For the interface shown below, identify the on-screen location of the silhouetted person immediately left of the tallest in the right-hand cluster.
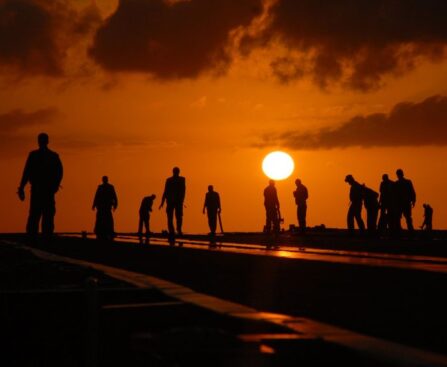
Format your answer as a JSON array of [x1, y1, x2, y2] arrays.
[[379, 173, 397, 232]]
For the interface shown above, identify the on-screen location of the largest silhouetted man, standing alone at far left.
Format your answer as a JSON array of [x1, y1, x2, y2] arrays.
[[17, 133, 63, 236]]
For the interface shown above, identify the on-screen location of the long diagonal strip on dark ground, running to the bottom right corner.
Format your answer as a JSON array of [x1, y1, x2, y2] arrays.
[[15, 244, 447, 367]]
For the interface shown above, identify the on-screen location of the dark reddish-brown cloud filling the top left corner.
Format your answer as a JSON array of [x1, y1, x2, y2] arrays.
[[0, 0, 100, 77]]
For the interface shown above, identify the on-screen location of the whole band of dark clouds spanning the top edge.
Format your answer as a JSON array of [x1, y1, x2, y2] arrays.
[[0, 0, 447, 91]]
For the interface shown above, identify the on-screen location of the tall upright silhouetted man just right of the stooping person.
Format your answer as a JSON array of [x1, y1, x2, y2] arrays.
[[159, 167, 186, 236]]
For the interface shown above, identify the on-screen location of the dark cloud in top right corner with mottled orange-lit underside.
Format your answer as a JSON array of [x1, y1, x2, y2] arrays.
[[242, 0, 447, 90]]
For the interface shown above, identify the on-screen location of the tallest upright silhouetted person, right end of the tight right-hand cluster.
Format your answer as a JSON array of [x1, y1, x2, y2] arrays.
[[395, 169, 416, 232]]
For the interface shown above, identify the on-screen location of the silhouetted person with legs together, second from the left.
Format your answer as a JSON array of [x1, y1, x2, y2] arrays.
[[92, 176, 118, 240]]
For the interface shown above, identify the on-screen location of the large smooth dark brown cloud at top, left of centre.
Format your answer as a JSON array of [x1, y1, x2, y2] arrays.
[[90, 0, 262, 79]]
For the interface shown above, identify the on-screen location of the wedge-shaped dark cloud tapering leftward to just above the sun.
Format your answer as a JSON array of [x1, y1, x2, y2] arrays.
[[261, 96, 447, 150]]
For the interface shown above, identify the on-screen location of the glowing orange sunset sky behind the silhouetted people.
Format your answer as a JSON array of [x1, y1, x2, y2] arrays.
[[0, 0, 447, 233]]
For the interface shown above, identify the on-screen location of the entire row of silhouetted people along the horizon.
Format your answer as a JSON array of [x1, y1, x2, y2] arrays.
[[18, 133, 433, 240]]
